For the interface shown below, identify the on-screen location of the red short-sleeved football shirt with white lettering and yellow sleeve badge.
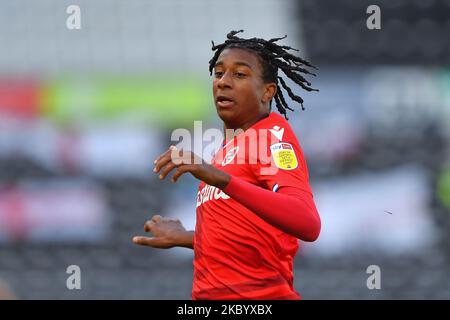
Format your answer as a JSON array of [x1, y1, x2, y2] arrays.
[[192, 112, 312, 299]]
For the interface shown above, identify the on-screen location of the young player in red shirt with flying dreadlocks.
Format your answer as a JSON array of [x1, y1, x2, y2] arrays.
[[133, 30, 321, 299]]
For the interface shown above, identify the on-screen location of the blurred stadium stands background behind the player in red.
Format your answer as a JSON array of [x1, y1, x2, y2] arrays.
[[0, 0, 450, 299]]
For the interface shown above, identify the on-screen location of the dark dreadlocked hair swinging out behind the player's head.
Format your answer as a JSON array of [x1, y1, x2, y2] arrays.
[[209, 30, 319, 119]]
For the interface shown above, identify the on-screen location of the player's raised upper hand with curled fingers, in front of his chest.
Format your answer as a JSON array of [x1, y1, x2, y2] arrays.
[[153, 146, 230, 189]]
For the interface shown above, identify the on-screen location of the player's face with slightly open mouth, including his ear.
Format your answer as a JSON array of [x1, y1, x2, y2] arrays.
[[213, 48, 276, 130]]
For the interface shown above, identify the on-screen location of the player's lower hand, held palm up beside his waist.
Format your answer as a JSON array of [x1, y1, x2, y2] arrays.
[[133, 215, 194, 249]]
